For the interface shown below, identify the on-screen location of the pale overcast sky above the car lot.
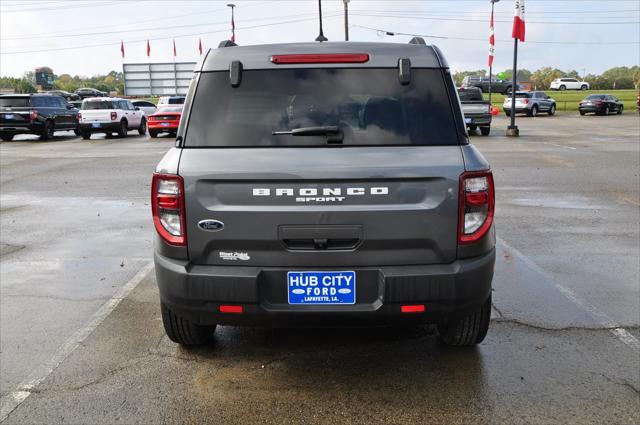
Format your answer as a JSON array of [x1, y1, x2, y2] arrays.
[[0, 0, 640, 76]]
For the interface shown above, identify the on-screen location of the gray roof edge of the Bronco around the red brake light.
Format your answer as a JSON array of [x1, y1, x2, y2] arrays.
[[202, 41, 449, 71]]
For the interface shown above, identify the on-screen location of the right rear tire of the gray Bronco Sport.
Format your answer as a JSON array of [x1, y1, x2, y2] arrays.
[[438, 296, 491, 347]]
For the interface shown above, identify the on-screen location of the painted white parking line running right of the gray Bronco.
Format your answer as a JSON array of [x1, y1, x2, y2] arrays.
[[496, 238, 640, 352]]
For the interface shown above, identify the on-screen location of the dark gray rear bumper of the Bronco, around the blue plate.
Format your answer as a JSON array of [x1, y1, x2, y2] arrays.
[[154, 249, 495, 326]]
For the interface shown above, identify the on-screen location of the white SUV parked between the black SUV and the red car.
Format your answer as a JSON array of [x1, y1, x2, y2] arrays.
[[78, 97, 147, 139]]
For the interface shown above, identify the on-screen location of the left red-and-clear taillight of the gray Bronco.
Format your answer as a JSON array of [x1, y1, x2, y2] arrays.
[[151, 173, 187, 246]]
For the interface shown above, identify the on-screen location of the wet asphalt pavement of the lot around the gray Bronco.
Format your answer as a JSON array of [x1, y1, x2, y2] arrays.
[[0, 113, 640, 423]]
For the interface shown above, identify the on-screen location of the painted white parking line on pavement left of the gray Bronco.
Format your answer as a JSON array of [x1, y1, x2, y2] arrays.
[[0, 261, 153, 422]]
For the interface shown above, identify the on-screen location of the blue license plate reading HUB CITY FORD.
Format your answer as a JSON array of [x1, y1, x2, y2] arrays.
[[287, 271, 356, 304]]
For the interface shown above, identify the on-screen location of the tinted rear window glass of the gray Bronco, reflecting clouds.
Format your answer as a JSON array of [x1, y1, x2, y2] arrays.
[[185, 68, 458, 147]]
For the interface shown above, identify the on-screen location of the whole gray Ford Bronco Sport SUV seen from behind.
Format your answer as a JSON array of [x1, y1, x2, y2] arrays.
[[151, 38, 495, 345]]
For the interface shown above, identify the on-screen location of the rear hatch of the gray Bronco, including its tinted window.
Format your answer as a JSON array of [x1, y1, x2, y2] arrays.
[[179, 68, 464, 267]]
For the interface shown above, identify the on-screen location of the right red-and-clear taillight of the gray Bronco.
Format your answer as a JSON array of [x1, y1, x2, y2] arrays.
[[458, 171, 495, 244]]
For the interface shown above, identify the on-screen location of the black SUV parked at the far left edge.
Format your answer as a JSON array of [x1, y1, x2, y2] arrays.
[[0, 93, 78, 141]]
